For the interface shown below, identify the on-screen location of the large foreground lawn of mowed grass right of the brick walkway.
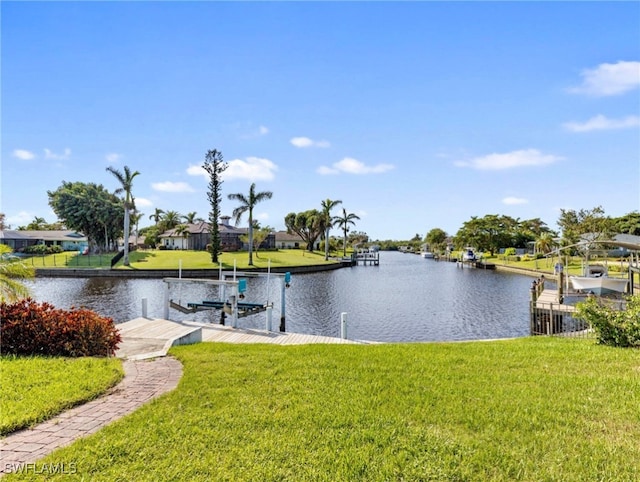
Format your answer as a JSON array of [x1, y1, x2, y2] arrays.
[[18, 338, 640, 481]]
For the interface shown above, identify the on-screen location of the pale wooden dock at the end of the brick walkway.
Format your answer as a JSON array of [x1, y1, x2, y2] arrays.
[[116, 317, 376, 360]]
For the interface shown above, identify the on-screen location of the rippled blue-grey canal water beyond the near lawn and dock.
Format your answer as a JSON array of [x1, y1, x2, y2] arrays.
[[23, 252, 531, 342]]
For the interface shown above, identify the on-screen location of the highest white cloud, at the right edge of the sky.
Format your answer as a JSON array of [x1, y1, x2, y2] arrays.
[[569, 61, 640, 97]]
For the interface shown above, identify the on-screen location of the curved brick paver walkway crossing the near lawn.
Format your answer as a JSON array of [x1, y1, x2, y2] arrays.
[[0, 357, 182, 474]]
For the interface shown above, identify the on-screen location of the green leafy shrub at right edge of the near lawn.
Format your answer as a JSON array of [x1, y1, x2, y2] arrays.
[[577, 295, 640, 347]]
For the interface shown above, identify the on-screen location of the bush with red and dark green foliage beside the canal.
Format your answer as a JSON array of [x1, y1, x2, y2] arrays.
[[0, 298, 122, 357]]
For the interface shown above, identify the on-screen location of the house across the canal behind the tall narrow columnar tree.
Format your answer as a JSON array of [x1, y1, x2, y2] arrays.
[[160, 216, 276, 251]]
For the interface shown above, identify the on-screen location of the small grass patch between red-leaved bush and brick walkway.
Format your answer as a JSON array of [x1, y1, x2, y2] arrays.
[[0, 355, 124, 435]]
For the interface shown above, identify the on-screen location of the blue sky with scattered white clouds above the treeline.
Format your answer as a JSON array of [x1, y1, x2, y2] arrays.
[[0, 1, 640, 240]]
